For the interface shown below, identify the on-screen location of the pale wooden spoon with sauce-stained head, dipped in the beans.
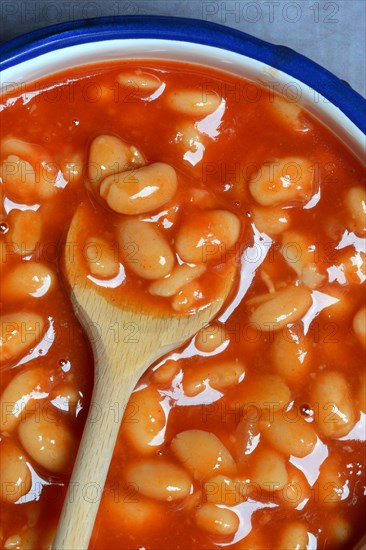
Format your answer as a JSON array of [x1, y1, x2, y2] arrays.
[[53, 205, 235, 550]]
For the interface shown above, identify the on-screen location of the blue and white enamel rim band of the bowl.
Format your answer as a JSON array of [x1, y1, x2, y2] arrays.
[[0, 12, 366, 548]]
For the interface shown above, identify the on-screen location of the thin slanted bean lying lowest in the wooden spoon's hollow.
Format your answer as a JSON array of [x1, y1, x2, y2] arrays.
[[149, 264, 206, 297]]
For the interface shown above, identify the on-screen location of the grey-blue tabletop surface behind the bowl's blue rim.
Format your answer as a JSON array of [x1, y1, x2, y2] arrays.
[[0, 0, 366, 97]]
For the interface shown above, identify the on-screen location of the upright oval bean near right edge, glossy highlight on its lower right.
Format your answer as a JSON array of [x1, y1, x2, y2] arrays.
[[310, 370, 357, 438]]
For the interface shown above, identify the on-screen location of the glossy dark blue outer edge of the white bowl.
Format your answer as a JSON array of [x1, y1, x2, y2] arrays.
[[0, 15, 366, 134]]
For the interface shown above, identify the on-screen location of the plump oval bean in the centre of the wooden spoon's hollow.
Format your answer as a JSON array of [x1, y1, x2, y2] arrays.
[[119, 218, 174, 279]]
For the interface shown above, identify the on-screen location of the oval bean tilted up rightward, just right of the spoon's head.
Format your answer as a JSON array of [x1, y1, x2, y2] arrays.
[[251, 285, 312, 331]]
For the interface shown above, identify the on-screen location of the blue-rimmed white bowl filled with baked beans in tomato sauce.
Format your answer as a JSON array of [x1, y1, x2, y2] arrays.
[[0, 17, 366, 550]]
